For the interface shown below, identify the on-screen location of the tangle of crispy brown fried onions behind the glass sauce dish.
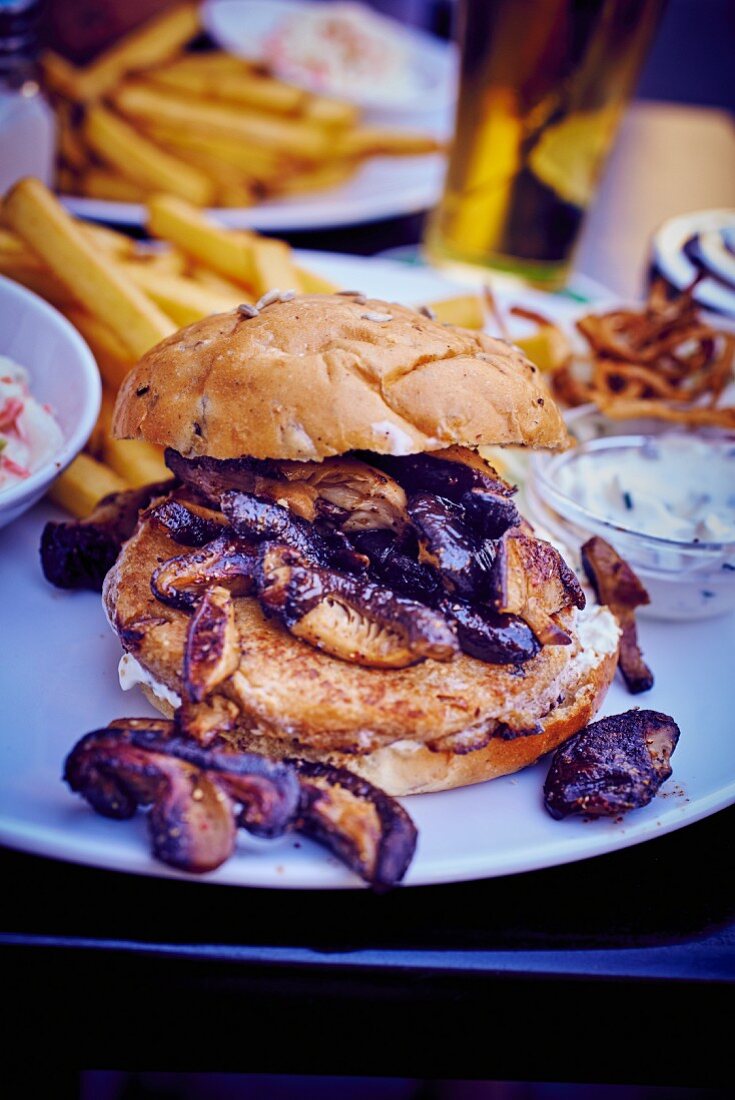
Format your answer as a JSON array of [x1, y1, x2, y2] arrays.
[[543, 282, 735, 429]]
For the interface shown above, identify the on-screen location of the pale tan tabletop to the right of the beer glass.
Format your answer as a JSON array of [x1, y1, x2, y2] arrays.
[[574, 101, 735, 297]]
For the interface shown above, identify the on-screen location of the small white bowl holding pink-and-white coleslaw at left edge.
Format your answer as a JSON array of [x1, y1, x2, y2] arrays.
[[0, 276, 101, 527]]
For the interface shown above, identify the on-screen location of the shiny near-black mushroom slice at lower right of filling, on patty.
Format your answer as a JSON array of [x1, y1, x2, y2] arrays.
[[440, 600, 541, 664]]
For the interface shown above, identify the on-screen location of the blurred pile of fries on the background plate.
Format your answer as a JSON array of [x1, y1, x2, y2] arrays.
[[42, 3, 439, 207]]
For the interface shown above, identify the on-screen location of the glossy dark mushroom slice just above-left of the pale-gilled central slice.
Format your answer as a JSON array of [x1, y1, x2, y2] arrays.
[[221, 492, 366, 572]]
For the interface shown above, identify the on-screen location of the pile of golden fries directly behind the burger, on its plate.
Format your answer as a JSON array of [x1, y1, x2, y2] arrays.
[[0, 179, 484, 517]]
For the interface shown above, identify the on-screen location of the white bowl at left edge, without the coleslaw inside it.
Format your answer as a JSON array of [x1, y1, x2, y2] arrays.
[[0, 276, 102, 527]]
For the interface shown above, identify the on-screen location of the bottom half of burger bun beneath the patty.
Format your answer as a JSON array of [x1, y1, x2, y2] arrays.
[[140, 607, 619, 795]]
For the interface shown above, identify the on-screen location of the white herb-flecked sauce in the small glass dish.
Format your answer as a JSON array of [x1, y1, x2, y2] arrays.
[[553, 435, 735, 543]]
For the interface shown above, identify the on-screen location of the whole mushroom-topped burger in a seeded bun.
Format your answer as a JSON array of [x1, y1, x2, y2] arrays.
[[103, 293, 619, 795]]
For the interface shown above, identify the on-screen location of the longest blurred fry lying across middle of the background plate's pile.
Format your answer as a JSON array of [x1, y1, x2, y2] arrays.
[[114, 81, 334, 161]]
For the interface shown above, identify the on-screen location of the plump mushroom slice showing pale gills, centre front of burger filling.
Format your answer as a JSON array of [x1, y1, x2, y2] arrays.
[[259, 543, 457, 669]]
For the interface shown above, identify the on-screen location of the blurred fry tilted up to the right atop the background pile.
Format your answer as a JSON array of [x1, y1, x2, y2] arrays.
[[49, 3, 200, 102]]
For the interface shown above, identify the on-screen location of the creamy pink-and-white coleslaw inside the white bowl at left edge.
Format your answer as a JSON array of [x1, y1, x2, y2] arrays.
[[0, 355, 64, 492]]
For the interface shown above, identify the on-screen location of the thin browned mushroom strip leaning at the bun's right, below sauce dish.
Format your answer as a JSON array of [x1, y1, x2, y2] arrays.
[[581, 535, 654, 695]]
